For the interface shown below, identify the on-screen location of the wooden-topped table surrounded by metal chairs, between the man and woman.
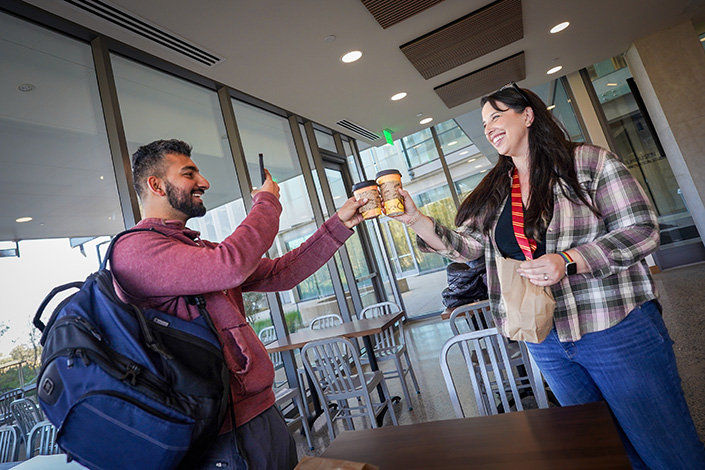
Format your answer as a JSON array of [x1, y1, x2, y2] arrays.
[[265, 310, 404, 426]]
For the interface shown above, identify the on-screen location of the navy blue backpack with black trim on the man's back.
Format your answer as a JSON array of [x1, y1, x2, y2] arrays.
[[34, 229, 230, 470]]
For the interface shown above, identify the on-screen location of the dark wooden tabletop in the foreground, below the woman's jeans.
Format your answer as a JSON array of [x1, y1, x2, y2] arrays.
[[321, 402, 631, 470]]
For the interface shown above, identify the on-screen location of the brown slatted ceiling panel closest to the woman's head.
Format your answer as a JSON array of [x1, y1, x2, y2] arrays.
[[434, 52, 526, 108]]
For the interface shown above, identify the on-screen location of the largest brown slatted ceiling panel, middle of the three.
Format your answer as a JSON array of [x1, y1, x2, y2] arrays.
[[399, 0, 524, 80]]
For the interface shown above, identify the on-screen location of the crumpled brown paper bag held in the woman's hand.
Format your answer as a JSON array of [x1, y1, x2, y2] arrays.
[[497, 256, 556, 343]]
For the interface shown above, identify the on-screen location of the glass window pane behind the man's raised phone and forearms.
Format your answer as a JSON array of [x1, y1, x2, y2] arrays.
[[233, 100, 340, 333]]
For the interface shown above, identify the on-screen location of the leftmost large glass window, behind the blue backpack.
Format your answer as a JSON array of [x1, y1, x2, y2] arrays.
[[0, 13, 119, 360]]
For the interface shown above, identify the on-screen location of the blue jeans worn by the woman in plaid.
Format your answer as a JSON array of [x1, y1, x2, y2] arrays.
[[526, 301, 705, 470]]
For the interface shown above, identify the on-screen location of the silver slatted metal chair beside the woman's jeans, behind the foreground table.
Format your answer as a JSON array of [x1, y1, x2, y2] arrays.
[[440, 328, 548, 418]]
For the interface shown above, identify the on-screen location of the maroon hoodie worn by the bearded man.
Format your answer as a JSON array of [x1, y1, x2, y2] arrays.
[[111, 192, 353, 432]]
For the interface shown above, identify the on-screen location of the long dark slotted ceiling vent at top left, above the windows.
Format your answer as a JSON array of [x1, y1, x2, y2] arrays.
[[64, 0, 223, 67]]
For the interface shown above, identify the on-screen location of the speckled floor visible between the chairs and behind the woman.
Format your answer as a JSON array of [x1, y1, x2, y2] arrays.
[[294, 263, 705, 455]]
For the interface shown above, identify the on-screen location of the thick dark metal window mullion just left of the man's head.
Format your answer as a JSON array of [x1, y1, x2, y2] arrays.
[[91, 36, 141, 228]]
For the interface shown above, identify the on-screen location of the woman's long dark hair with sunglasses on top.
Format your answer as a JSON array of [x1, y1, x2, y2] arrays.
[[455, 85, 598, 240]]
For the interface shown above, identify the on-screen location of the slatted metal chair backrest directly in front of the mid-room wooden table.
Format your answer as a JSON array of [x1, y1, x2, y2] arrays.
[[301, 338, 364, 397]]
